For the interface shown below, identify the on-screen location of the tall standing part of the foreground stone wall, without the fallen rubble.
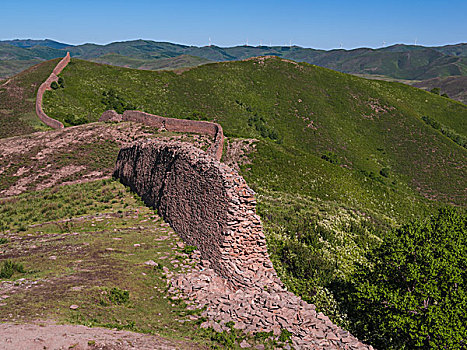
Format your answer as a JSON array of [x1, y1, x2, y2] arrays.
[[114, 141, 276, 287]]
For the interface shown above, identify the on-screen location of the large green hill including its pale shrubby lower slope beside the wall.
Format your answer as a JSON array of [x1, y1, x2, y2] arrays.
[[0, 57, 467, 348]]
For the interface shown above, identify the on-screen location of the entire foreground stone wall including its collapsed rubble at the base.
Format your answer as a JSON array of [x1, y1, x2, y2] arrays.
[[114, 141, 371, 349]]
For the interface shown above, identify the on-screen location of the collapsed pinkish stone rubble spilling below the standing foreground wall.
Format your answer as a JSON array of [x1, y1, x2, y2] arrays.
[[169, 264, 372, 349]]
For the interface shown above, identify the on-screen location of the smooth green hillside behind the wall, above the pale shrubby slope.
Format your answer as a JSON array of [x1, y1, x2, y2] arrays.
[[45, 58, 467, 212]]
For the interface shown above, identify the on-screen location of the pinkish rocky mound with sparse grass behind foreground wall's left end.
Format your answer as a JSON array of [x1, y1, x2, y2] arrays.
[[0, 123, 210, 198]]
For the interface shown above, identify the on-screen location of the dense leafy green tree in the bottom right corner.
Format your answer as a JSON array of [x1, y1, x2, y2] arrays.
[[348, 209, 467, 349]]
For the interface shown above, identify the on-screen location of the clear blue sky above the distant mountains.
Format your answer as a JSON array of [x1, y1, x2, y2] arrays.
[[0, 0, 467, 49]]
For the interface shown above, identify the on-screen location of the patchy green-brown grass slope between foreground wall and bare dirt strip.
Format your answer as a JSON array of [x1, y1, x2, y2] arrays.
[[0, 180, 287, 349]]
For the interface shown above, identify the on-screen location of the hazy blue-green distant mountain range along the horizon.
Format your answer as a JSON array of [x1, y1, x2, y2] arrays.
[[0, 39, 467, 102]]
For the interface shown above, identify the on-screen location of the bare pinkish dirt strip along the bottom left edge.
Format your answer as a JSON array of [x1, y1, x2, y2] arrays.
[[0, 323, 198, 350]]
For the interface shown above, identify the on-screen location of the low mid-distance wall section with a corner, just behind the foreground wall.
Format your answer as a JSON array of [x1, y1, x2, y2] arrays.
[[99, 110, 224, 160]]
